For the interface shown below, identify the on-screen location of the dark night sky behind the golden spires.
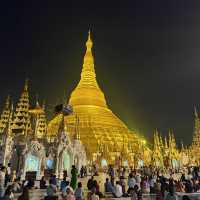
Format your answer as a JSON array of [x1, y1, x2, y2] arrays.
[[0, 0, 200, 144]]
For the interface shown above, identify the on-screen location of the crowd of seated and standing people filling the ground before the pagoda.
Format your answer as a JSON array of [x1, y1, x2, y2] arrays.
[[0, 164, 200, 200]]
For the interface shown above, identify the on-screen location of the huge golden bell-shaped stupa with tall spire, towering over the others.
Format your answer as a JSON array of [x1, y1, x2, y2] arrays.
[[48, 32, 139, 160]]
